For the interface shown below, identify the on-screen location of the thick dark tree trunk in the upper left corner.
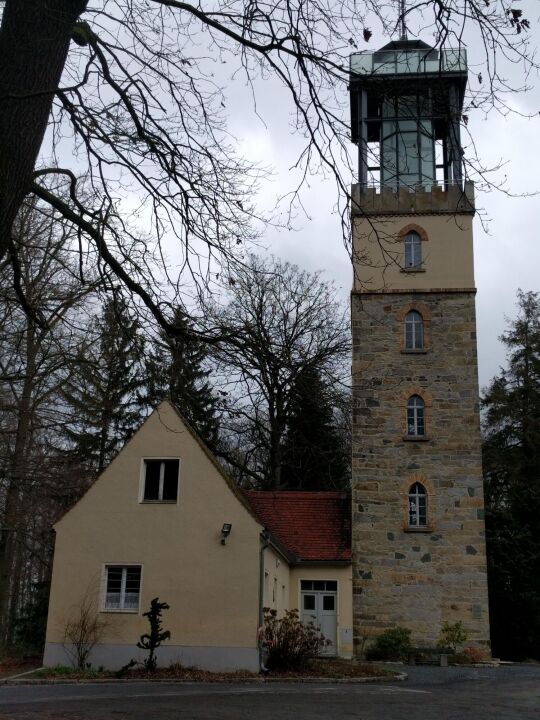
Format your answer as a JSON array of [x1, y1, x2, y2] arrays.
[[0, 0, 88, 258]]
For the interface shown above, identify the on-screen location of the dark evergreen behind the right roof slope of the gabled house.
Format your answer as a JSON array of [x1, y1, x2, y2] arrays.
[[147, 308, 218, 448]]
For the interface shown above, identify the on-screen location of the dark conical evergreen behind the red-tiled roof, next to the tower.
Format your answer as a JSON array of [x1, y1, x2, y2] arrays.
[[281, 366, 350, 490]]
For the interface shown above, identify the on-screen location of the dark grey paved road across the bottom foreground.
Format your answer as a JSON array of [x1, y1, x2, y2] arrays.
[[0, 666, 540, 720]]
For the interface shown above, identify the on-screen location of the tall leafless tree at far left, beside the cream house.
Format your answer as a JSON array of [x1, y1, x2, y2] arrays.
[[0, 197, 97, 644]]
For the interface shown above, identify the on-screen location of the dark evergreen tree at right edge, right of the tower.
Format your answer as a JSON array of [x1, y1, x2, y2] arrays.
[[484, 292, 540, 658]]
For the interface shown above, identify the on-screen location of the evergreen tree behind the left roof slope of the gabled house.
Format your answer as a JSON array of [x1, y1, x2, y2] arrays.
[[64, 296, 144, 472]]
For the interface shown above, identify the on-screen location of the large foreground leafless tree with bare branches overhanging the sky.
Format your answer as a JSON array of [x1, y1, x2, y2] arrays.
[[0, 0, 534, 332]]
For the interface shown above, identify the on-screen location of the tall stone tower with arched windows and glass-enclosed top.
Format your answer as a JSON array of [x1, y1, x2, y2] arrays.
[[350, 40, 489, 653]]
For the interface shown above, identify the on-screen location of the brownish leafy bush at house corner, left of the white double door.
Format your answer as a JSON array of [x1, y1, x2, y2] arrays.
[[261, 608, 330, 672]]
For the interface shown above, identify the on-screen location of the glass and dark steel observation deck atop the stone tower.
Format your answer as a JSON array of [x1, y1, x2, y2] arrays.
[[349, 39, 467, 190]]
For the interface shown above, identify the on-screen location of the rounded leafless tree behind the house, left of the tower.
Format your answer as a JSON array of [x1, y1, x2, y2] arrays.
[[209, 255, 350, 488]]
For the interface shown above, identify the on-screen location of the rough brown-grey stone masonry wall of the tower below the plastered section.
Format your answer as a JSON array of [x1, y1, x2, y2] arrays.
[[352, 291, 489, 653]]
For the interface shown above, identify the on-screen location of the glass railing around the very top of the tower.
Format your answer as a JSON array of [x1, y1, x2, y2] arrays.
[[350, 48, 467, 75]]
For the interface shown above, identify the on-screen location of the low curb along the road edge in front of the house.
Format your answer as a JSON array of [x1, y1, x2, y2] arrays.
[[0, 671, 408, 685]]
